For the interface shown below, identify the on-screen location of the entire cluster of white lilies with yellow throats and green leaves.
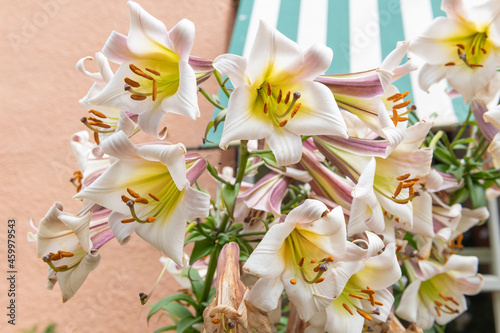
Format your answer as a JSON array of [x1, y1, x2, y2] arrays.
[[30, 0, 500, 333]]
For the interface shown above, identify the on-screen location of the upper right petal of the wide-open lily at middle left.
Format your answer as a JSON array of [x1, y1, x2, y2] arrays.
[[138, 143, 186, 190]]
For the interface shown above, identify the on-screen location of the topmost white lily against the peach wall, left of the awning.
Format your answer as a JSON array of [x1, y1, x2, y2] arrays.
[[88, 1, 200, 137]]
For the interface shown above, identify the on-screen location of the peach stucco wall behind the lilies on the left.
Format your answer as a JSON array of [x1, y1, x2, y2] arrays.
[[0, 0, 236, 332]]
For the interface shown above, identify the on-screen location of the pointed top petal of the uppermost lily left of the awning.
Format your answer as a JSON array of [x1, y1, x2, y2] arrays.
[[127, 1, 172, 60]]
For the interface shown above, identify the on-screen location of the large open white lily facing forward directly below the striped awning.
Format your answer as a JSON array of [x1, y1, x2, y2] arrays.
[[214, 21, 347, 166]]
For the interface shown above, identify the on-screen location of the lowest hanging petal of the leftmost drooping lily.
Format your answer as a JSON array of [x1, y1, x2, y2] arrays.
[[57, 250, 101, 303]]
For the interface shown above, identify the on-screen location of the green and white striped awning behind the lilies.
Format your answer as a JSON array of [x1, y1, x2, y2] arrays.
[[207, 0, 468, 142]]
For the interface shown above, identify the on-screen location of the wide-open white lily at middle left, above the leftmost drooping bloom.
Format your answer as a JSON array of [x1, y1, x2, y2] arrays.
[[75, 132, 210, 267]]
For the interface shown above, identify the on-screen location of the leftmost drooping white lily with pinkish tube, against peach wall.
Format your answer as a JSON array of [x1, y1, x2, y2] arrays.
[[35, 202, 113, 302]]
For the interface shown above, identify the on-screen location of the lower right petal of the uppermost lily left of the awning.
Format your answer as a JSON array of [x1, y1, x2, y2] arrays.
[[160, 60, 200, 120]]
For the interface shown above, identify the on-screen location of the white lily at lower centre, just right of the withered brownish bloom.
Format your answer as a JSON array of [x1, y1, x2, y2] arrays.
[[243, 200, 347, 321]]
